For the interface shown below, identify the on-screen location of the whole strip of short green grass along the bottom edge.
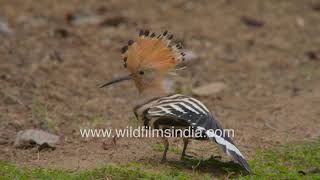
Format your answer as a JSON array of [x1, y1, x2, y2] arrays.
[[0, 141, 320, 180]]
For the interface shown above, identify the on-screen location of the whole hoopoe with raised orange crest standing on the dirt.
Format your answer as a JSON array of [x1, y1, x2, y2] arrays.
[[101, 30, 251, 173]]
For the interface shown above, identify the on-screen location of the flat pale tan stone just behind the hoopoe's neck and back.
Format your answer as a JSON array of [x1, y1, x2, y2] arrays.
[[192, 82, 226, 96]]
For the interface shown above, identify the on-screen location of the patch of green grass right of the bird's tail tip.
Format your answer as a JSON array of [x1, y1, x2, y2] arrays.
[[243, 140, 320, 179]]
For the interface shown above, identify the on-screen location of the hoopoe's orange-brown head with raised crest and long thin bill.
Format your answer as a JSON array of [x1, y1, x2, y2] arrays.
[[102, 30, 185, 93]]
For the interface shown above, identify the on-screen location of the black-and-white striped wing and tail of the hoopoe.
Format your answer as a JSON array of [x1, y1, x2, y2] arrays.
[[145, 94, 250, 172]]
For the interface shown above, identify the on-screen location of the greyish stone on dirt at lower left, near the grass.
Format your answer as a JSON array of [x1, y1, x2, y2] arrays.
[[14, 129, 60, 148]]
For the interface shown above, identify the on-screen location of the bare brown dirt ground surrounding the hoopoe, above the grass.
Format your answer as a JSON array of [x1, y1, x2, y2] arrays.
[[0, 0, 320, 176]]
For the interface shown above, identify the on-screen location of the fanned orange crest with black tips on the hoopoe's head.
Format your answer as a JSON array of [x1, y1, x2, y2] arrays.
[[122, 30, 185, 73]]
